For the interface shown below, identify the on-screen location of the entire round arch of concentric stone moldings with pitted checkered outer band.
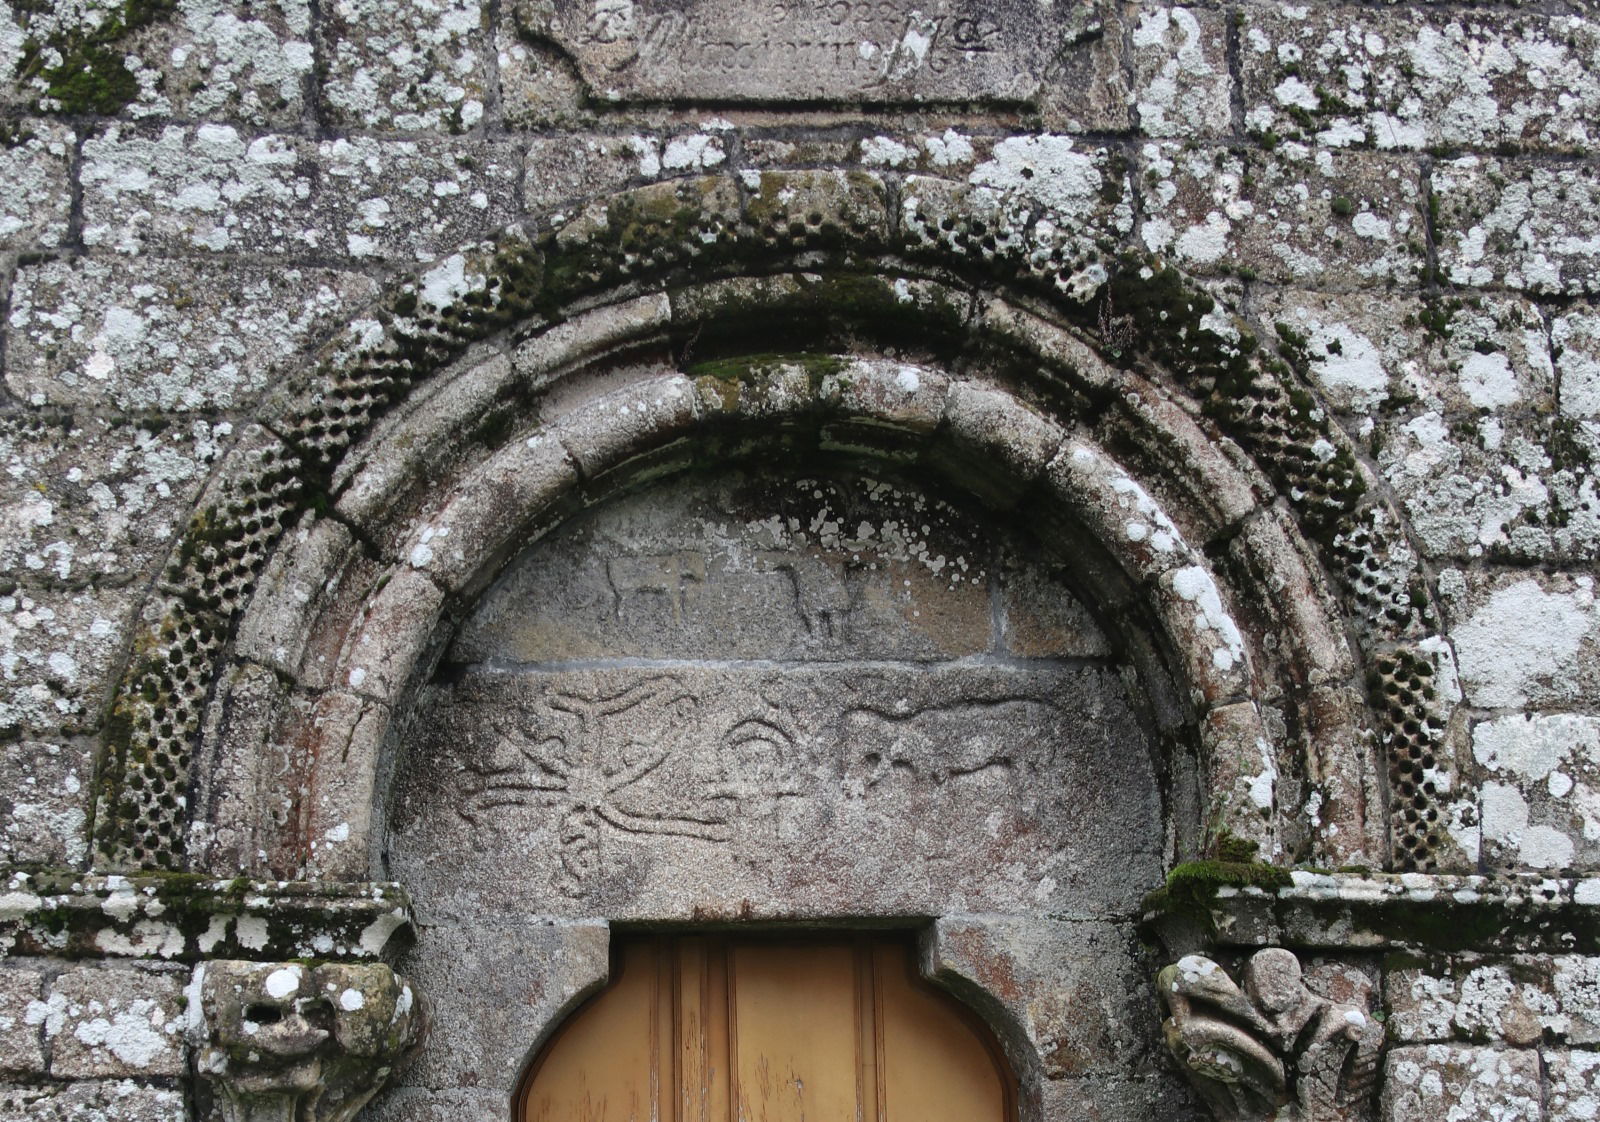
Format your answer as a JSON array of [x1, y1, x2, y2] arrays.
[[96, 173, 1448, 877]]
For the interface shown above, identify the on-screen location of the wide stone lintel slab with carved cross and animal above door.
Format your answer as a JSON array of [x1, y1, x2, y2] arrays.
[[390, 664, 1158, 919]]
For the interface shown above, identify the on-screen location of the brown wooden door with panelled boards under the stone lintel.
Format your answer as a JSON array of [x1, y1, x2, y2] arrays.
[[518, 936, 1016, 1122]]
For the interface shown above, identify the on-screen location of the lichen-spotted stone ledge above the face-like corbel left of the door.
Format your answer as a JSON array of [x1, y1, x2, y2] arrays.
[[0, 869, 413, 962]]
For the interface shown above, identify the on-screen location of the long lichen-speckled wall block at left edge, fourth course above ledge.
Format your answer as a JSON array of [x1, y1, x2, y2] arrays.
[[6, 258, 378, 411]]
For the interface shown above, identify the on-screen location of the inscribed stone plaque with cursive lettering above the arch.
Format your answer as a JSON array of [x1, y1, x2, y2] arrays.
[[518, 0, 1088, 104]]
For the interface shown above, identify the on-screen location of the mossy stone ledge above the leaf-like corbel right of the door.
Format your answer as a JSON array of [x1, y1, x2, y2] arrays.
[[1141, 861, 1600, 956]]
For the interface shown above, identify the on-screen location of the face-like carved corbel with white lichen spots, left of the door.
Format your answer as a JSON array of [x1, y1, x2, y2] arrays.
[[195, 962, 421, 1122]]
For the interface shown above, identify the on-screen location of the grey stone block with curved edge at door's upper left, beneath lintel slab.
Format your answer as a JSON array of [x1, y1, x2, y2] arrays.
[[400, 919, 610, 1088]]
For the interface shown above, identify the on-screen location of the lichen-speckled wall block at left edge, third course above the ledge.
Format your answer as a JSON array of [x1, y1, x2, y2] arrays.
[[0, 413, 234, 584]]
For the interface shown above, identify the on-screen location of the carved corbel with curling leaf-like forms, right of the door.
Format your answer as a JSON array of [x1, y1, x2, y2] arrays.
[[1157, 948, 1384, 1122]]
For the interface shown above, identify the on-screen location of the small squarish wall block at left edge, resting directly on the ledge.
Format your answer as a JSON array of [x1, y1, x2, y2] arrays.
[[0, 738, 94, 866]]
